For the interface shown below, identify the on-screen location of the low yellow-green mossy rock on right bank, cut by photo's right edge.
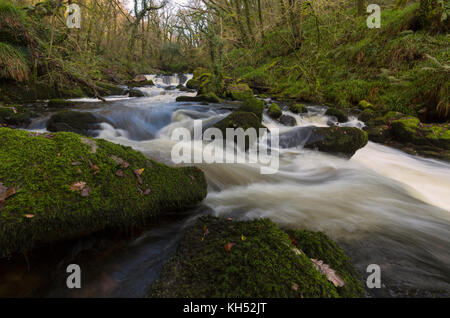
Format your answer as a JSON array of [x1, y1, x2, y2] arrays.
[[391, 117, 450, 149]]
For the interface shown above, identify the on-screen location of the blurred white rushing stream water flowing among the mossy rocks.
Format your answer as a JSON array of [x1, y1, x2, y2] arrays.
[[4, 76, 450, 297]]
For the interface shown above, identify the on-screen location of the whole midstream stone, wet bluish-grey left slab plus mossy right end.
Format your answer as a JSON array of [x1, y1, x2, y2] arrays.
[[280, 126, 368, 158]]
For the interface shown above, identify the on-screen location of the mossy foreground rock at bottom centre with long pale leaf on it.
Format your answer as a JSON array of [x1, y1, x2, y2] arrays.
[[149, 216, 363, 298]]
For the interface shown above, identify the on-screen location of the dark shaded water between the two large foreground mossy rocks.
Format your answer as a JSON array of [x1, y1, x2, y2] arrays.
[[0, 206, 210, 298]]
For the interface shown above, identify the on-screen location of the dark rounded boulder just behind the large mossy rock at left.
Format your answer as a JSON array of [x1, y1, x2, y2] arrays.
[[47, 111, 100, 136]]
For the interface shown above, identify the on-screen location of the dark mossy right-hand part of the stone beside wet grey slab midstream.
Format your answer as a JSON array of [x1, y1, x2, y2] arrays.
[[305, 127, 369, 158]]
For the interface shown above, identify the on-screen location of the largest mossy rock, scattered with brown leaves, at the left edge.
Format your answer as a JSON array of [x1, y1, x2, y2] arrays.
[[0, 128, 207, 257]]
